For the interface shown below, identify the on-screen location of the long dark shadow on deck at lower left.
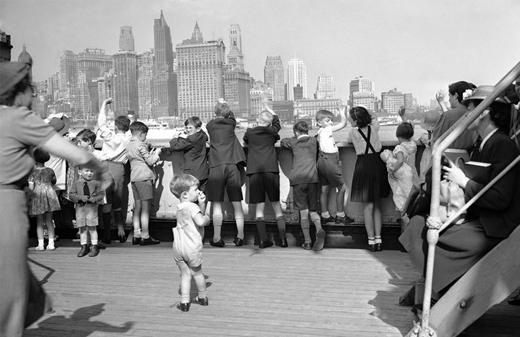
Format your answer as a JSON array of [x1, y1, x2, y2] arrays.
[[28, 303, 134, 337]]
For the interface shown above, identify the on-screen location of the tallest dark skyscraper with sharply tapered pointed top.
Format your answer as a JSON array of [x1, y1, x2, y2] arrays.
[[152, 11, 178, 118]]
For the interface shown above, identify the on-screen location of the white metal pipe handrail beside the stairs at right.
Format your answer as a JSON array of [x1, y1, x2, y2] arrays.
[[418, 62, 520, 336]]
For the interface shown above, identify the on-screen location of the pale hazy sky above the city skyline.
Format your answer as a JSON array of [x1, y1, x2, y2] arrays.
[[0, 0, 520, 104]]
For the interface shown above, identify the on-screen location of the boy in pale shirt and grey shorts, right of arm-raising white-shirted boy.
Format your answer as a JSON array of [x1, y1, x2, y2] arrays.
[[126, 122, 161, 246]]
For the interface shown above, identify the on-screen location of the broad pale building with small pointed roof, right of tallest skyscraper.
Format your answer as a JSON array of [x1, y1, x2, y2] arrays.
[[176, 24, 226, 121]]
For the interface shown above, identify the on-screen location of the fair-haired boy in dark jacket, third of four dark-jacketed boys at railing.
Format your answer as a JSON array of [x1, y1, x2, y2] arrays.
[[244, 99, 288, 248]]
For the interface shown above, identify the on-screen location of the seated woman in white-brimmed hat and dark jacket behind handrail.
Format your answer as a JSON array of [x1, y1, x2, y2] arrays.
[[399, 86, 520, 299]]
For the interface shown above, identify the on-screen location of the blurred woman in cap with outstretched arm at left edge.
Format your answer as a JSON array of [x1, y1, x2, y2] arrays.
[[0, 62, 110, 336]]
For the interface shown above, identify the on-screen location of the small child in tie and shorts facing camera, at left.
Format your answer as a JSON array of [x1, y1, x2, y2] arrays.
[[69, 167, 105, 257]]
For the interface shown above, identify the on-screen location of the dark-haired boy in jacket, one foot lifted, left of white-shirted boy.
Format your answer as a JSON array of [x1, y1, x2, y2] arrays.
[[280, 121, 326, 251]]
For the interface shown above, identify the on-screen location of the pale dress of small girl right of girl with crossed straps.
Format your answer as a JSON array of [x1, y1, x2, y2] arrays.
[[380, 150, 413, 213]]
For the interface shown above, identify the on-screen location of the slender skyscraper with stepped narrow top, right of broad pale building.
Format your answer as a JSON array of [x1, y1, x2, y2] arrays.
[[224, 25, 251, 118]]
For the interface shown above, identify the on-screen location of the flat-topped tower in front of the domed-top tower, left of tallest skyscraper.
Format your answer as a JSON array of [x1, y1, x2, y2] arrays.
[[113, 51, 139, 117]]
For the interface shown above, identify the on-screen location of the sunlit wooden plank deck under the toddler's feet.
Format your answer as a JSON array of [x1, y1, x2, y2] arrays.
[[24, 240, 520, 337]]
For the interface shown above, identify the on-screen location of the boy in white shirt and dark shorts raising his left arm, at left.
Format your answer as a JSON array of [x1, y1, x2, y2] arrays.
[[97, 98, 130, 244]]
